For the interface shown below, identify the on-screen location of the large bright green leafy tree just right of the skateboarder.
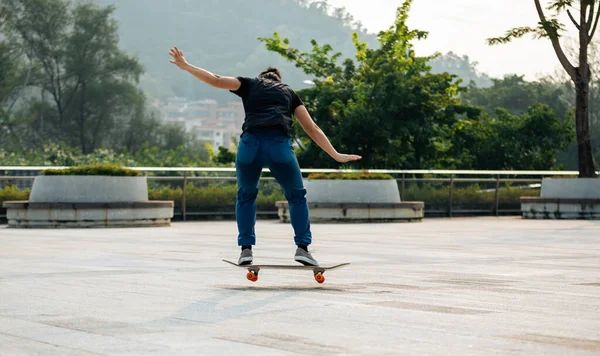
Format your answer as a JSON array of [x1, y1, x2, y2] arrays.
[[260, 0, 477, 168]]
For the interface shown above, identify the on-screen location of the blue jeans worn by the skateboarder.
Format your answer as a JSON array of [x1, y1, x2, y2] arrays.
[[235, 127, 312, 246]]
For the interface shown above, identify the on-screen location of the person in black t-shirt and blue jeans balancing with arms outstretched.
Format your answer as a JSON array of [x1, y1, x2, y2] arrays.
[[169, 46, 362, 266]]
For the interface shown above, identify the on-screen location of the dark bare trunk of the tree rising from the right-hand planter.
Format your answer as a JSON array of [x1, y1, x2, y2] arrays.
[[575, 68, 596, 178]]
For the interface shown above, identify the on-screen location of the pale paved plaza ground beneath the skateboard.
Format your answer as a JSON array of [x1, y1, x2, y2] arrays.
[[0, 218, 600, 355]]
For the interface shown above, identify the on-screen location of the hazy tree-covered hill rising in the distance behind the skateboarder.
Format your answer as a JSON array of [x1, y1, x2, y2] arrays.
[[96, 0, 377, 101]]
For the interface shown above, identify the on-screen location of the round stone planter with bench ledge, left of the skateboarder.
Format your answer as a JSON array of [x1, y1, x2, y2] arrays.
[[3, 176, 173, 228]]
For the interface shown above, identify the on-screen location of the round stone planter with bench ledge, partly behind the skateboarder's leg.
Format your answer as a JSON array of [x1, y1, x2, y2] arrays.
[[276, 179, 424, 223]]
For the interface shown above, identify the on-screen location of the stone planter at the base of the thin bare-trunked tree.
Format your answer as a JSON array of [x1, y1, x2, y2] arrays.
[[521, 178, 600, 220]]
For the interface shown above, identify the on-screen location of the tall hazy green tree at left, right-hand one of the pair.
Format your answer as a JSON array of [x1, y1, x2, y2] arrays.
[[65, 3, 143, 153]]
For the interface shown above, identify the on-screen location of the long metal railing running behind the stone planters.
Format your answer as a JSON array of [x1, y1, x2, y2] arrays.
[[0, 166, 579, 221]]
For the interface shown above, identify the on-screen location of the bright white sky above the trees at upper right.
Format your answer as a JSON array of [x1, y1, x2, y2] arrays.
[[328, 0, 580, 80]]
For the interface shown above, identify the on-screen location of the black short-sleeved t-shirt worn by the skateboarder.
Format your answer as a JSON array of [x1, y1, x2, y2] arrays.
[[231, 77, 304, 136]]
